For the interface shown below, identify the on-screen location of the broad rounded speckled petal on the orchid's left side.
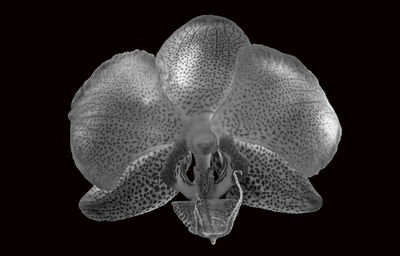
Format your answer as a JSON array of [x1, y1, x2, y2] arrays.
[[69, 51, 183, 190]]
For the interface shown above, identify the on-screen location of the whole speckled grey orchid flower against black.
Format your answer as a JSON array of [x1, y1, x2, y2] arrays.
[[68, 15, 341, 244]]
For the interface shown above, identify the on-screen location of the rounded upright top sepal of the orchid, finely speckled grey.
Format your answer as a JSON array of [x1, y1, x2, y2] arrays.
[[157, 15, 250, 116]]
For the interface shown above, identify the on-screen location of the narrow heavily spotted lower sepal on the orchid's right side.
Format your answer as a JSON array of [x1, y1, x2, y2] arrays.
[[227, 141, 322, 213]]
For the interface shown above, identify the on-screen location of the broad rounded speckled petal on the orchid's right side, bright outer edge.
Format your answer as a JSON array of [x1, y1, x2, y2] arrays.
[[212, 45, 341, 177]]
